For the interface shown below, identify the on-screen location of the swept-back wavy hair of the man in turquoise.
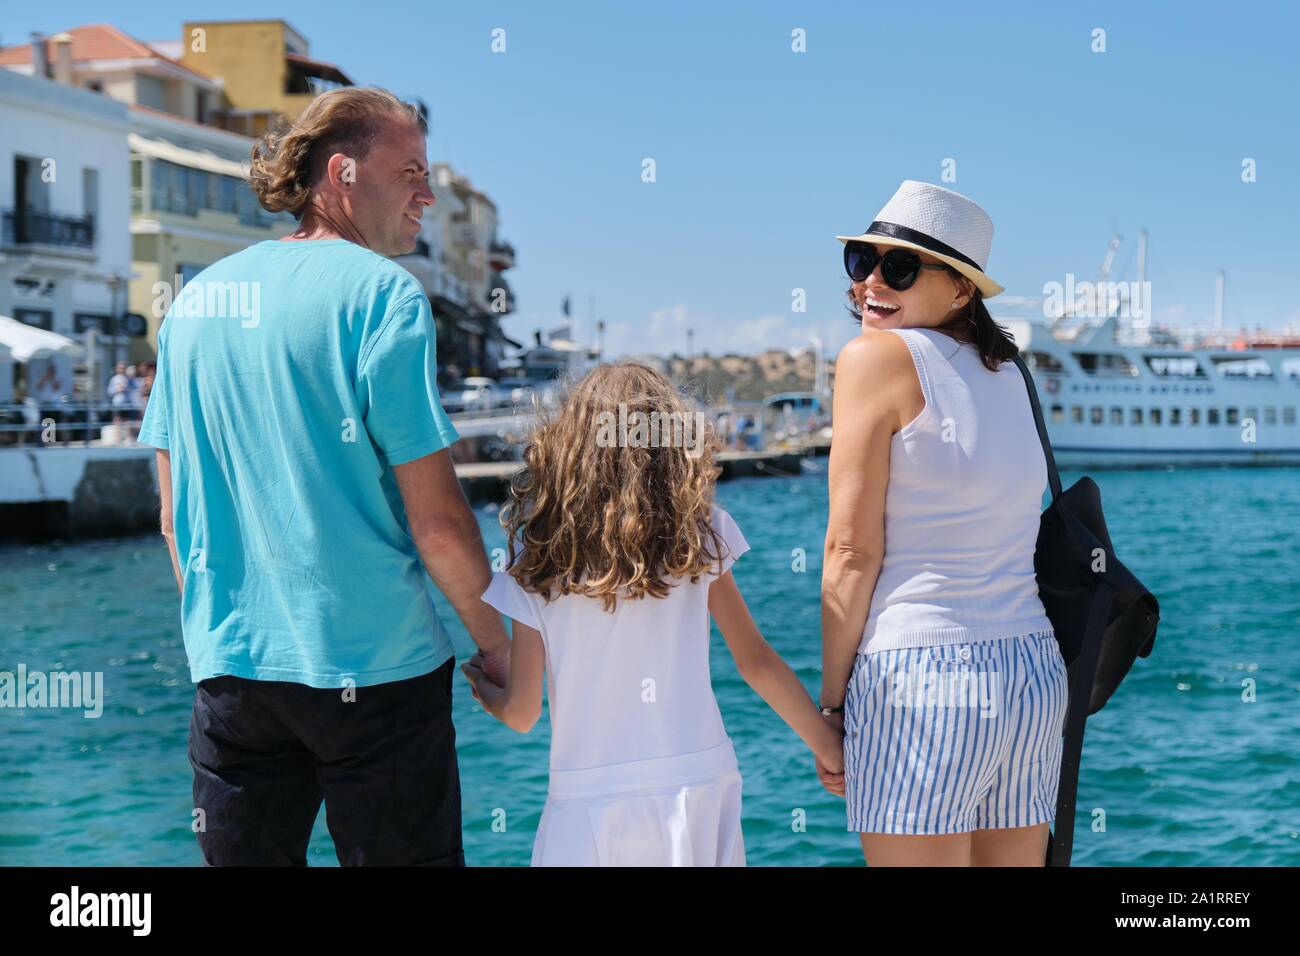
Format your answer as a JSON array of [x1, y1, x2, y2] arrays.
[[248, 86, 429, 220]]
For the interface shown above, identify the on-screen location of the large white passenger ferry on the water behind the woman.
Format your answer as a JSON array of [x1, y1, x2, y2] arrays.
[[1000, 316, 1300, 467]]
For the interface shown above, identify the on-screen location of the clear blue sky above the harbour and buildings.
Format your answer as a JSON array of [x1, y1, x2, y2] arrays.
[[0, 0, 1300, 354]]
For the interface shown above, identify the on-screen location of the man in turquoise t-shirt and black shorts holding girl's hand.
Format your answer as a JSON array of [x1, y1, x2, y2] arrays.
[[140, 87, 510, 865]]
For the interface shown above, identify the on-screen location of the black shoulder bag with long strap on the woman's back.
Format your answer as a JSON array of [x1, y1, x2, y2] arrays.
[[1014, 355, 1160, 866]]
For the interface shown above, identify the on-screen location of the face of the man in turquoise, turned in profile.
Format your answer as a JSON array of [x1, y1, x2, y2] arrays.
[[347, 124, 434, 256]]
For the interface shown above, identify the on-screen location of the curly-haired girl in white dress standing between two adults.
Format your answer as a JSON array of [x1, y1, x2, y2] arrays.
[[463, 363, 842, 866]]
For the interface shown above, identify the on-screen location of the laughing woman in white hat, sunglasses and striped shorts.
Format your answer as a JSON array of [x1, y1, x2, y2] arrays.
[[818, 179, 1066, 866]]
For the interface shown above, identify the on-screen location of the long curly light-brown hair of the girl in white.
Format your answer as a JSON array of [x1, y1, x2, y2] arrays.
[[501, 362, 725, 611]]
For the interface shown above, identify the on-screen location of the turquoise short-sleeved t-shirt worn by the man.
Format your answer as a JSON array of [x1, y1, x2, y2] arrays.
[[140, 239, 460, 687]]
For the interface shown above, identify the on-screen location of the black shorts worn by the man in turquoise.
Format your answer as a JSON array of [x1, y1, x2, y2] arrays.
[[190, 658, 465, 866]]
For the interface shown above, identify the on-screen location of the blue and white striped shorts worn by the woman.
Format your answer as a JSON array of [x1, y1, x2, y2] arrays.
[[844, 631, 1069, 834]]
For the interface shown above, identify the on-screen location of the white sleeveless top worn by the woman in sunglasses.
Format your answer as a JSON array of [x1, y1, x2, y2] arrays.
[[858, 329, 1052, 653]]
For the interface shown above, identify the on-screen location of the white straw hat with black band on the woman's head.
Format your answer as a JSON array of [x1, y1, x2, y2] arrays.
[[835, 179, 1002, 299]]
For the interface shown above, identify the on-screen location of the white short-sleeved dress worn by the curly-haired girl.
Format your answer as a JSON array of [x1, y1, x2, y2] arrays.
[[482, 506, 749, 866]]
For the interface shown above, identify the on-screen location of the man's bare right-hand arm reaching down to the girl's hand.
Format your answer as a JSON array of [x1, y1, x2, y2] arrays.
[[393, 449, 510, 660]]
